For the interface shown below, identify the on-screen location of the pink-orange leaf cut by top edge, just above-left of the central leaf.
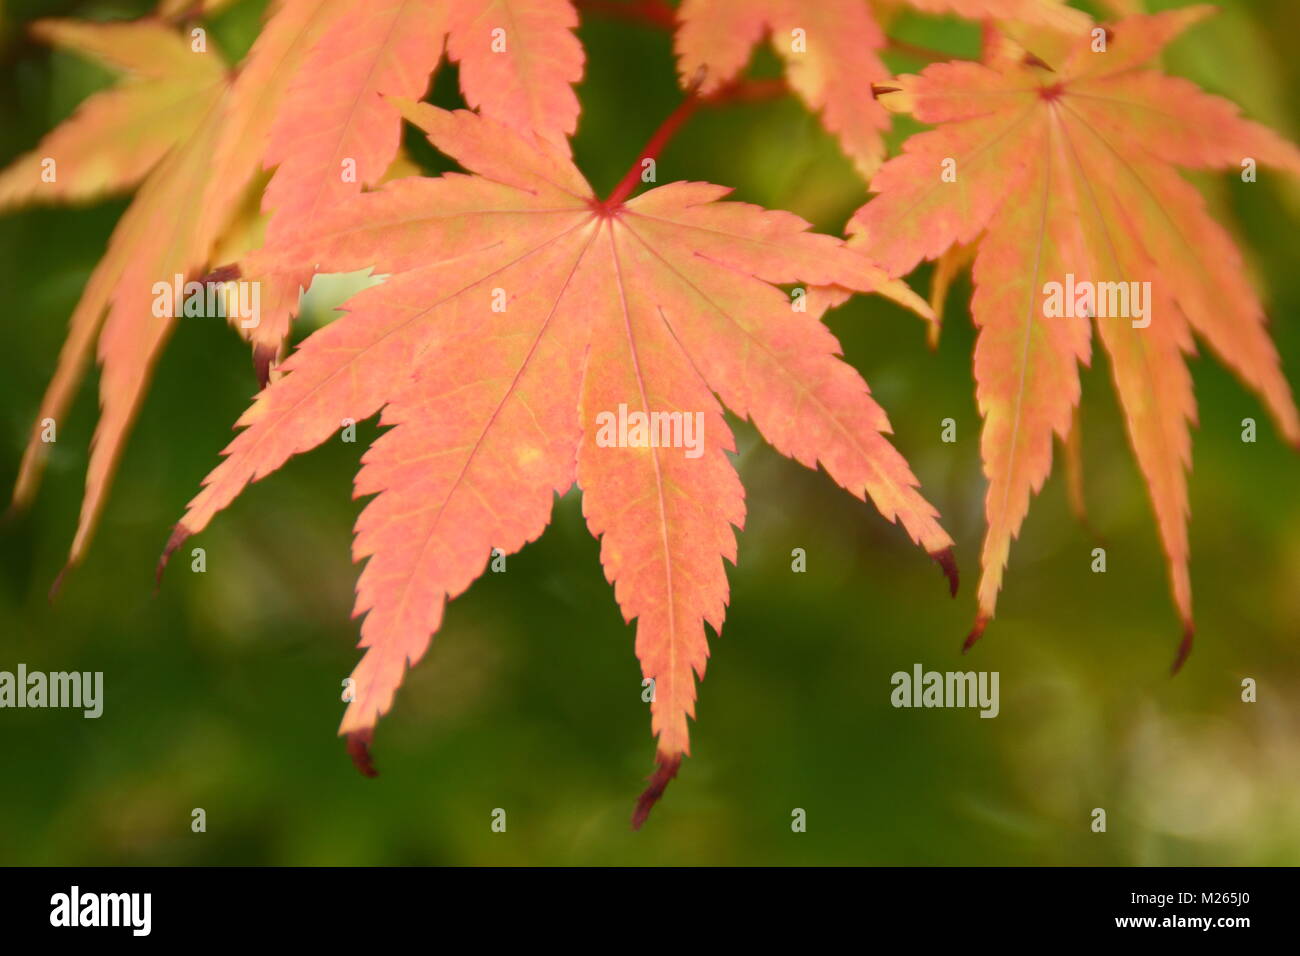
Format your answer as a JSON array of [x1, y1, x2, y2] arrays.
[[251, 0, 584, 376]]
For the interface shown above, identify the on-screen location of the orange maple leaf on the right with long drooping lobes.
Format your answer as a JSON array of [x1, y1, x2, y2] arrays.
[[850, 8, 1300, 671]]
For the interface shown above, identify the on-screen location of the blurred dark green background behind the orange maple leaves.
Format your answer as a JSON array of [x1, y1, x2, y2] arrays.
[[0, 0, 1300, 865]]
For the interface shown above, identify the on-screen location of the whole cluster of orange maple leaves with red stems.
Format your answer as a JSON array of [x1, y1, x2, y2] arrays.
[[0, 0, 1300, 825]]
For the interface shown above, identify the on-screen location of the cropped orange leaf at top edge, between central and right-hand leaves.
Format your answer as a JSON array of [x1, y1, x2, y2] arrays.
[[675, 0, 1089, 178]]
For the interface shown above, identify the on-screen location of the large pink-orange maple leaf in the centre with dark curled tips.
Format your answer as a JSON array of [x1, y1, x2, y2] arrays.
[[159, 101, 957, 825]]
